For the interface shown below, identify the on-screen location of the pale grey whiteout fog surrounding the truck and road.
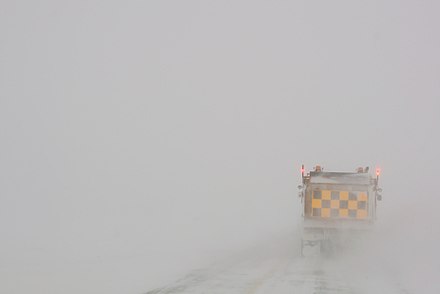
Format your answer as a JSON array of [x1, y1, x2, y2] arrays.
[[0, 1, 440, 293]]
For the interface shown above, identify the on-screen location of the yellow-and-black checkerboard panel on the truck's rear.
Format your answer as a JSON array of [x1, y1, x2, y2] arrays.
[[312, 190, 368, 219]]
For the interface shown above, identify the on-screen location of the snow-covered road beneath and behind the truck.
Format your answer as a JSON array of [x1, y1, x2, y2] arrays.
[[147, 234, 409, 294]]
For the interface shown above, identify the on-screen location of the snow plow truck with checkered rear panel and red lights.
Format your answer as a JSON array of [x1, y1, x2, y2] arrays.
[[298, 165, 382, 256]]
